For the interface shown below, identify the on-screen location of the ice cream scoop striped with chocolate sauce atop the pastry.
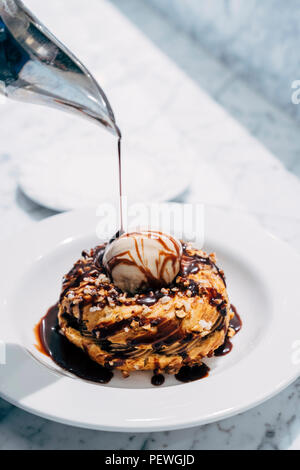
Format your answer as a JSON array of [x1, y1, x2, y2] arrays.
[[103, 231, 182, 293]]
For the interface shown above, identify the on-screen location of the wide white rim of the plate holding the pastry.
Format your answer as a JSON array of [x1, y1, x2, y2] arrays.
[[0, 207, 300, 432]]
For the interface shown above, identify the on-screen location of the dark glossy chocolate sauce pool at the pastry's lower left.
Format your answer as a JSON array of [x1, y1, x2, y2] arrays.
[[35, 304, 113, 384]]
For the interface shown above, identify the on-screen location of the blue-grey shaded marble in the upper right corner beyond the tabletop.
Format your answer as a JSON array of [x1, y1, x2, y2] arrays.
[[148, 0, 300, 121]]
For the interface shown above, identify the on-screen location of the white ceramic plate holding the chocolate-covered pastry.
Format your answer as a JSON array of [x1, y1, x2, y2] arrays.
[[0, 208, 300, 432]]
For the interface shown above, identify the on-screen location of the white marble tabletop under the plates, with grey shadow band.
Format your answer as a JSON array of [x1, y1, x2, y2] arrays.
[[0, 0, 300, 449]]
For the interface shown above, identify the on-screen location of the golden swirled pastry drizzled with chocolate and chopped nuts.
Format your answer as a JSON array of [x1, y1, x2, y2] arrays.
[[59, 243, 232, 375]]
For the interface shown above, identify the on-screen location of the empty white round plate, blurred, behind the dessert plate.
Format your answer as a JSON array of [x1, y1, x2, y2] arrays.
[[16, 109, 195, 211]]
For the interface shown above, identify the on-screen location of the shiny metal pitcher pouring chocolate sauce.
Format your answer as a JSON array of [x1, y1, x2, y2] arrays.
[[0, 0, 120, 137]]
